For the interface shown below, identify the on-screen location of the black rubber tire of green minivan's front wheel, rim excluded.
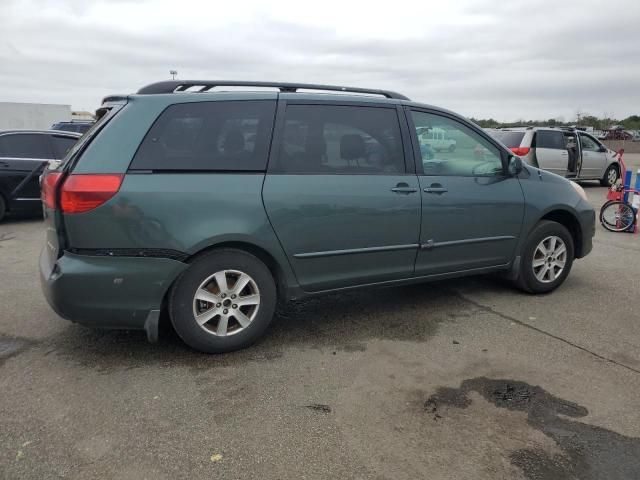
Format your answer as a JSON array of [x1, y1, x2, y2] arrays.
[[519, 220, 575, 293]]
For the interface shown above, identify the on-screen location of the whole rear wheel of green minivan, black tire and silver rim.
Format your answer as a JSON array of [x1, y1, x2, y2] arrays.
[[169, 249, 278, 353]]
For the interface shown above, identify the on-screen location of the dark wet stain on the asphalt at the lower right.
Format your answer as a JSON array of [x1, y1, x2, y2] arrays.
[[424, 377, 640, 480]]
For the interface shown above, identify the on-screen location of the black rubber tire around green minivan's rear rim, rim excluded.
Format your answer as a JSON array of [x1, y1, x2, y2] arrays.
[[169, 249, 277, 353]]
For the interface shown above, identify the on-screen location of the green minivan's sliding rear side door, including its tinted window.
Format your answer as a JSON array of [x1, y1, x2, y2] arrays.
[[263, 99, 420, 291]]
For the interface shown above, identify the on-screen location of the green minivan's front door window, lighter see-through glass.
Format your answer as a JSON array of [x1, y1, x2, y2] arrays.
[[411, 111, 503, 177]]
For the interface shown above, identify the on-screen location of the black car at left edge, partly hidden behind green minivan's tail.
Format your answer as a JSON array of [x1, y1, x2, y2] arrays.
[[0, 130, 80, 221]]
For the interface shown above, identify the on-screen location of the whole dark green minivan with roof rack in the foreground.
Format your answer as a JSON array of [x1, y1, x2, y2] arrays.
[[40, 81, 595, 352]]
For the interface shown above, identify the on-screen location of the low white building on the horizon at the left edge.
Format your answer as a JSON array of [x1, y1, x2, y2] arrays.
[[0, 102, 71, 130]]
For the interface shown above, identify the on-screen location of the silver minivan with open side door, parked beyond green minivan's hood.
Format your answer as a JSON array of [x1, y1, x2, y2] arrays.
[[489, 127, 620, 187]]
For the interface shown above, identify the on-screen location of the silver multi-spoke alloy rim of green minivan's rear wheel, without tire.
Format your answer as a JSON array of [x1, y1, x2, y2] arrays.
[[193, 270, 260, 337]]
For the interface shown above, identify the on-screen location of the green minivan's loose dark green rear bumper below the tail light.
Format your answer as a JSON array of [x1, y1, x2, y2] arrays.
[[40, 247, 187, 329]]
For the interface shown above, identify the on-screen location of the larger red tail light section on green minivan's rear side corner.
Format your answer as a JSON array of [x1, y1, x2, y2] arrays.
[[60, 174, 123, 213]]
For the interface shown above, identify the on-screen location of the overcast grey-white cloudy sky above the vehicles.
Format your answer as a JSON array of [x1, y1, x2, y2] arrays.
[[0, 0, 640, 120]]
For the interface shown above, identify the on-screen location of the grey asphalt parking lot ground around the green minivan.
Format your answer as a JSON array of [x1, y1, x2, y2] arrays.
[[0, 154, 640, 480]]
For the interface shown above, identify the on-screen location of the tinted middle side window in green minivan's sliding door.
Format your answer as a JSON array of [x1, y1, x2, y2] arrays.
[[272, 105, 405, 174]]
